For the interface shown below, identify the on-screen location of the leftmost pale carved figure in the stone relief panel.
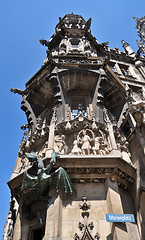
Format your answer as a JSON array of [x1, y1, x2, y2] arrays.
[[54, 135, 66, 154]]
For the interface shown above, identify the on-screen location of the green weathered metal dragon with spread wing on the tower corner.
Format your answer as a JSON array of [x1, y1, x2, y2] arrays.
[[21, 152, 74, 222]]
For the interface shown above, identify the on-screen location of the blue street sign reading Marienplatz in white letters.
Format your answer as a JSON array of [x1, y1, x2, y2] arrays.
[[106, 214, 135, 222]]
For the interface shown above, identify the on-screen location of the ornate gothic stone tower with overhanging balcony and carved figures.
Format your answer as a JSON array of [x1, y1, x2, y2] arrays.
[[3, 13, 145, 240]]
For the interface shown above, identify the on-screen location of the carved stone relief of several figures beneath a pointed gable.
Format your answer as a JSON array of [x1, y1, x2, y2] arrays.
[[54, 114, 110, 155]]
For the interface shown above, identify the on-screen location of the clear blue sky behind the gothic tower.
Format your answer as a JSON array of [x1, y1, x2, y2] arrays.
[[0, 0, 145, 236]]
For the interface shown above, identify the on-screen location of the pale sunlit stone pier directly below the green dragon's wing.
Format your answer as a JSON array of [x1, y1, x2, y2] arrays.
[[44, 195, 62, 240]]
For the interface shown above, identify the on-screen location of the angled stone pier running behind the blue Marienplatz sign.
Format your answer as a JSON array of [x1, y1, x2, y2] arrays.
[[106, 178, 129, 240]]
